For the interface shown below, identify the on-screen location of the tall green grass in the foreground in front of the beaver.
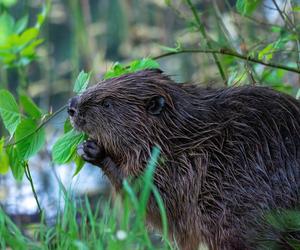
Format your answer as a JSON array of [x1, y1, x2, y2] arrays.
[[0, 149, 172, 250]]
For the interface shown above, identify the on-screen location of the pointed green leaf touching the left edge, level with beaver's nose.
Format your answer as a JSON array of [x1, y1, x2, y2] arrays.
[[0, 90, 21, 136]]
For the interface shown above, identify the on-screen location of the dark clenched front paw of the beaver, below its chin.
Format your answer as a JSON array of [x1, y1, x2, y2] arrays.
[[77, 140, 105, 165]]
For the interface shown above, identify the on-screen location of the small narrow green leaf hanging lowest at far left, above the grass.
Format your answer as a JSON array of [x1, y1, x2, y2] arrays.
[[6, 145, 25, 181]]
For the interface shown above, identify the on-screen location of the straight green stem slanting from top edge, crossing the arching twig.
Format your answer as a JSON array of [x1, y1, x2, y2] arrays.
[[186, 0, 227, 82]]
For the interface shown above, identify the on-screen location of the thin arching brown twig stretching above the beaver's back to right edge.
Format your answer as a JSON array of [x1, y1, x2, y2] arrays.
[[152, 48, 300, 74]]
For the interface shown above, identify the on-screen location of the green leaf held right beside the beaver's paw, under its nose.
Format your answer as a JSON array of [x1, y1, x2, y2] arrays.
[[52, 129, 85, 164]]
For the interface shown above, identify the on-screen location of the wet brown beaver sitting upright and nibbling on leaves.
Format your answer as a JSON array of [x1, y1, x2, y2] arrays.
[[68, 70, 300, 250]]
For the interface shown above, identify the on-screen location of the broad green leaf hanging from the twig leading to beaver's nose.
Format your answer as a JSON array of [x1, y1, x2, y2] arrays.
[[15, 119, 45, 160]]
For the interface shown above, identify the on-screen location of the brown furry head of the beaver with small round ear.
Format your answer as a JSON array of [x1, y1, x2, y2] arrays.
[[68, 70, 202, 173]]
